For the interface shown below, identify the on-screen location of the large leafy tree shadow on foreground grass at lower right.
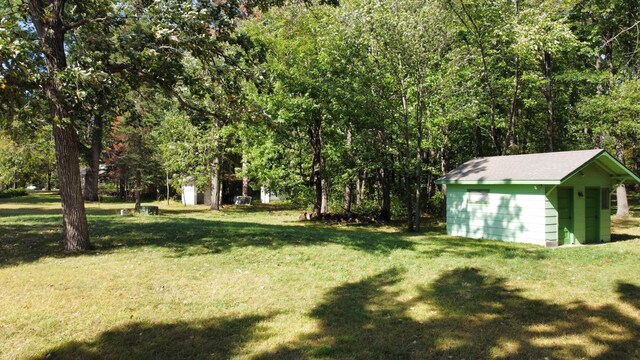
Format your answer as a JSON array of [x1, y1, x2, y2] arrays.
[[257, 268, 640, 359]]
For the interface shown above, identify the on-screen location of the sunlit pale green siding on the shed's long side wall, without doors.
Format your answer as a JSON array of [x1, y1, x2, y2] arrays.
[[447, 184, 547, 245]]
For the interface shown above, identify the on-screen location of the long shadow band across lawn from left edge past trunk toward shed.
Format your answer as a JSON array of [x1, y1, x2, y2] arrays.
[[0, 211, 546, 267]]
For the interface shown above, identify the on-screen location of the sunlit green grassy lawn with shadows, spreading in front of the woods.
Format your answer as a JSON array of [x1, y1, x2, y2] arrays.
[[0, 194, 640, 359]]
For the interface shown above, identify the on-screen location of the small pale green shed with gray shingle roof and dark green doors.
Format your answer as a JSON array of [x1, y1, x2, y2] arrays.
[[436, 149, 640, 246]]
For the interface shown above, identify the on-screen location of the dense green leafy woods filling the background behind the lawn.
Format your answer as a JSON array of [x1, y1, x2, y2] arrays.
[[0, 0, 640, 251]]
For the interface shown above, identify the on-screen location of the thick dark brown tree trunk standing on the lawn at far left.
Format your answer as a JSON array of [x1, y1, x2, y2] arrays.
[[28, 0, 91, 251]]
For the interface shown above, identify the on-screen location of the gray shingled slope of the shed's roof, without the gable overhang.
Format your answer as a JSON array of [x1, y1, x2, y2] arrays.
[[438, 149, 605, 184]]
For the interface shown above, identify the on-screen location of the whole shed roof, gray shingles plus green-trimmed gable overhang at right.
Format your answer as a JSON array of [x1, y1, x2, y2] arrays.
[[436, 149, 640, 184]]
